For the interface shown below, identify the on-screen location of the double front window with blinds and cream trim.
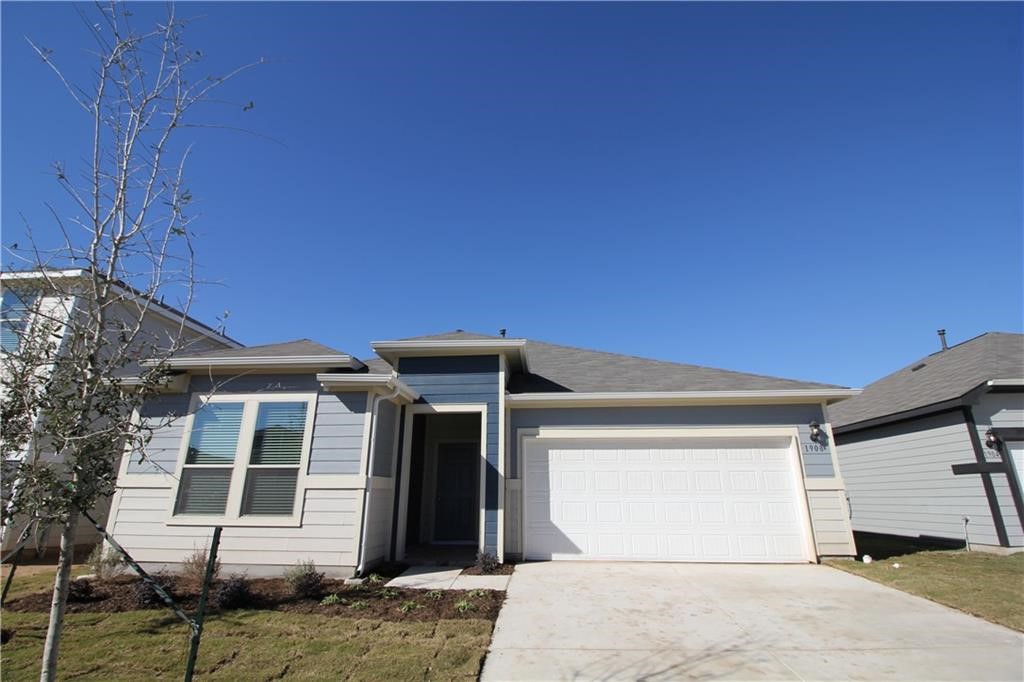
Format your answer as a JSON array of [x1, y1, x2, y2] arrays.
[[174, 394, 315, 521]]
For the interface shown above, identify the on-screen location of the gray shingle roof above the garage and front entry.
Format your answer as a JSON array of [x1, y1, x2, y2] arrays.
[[393, 330, 842, 393]]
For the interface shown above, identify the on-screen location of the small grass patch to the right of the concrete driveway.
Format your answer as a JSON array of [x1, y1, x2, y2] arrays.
[[828, 551, 1024, 632]]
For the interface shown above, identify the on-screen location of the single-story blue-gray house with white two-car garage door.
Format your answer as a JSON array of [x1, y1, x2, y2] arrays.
[[111, 331, 857, 576]]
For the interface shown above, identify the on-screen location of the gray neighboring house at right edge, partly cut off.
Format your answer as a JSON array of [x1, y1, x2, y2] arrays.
[[829, 332, 1024, 551]]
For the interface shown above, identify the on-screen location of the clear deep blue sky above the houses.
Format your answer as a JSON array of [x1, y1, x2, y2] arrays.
[[0, 2, 1024, 386]]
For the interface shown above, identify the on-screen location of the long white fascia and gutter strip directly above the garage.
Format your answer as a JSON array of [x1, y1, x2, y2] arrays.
[[506, 388, 861, 408]]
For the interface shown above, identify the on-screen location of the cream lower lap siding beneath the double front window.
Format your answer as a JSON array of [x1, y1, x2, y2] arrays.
[[112, 488, 362, 570]]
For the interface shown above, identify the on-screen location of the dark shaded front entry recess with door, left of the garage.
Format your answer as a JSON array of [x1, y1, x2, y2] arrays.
[[404, 413, 481, 558]]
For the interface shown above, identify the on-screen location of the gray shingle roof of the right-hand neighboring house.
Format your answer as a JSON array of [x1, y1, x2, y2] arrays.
[[828, 332, 1024, 430]]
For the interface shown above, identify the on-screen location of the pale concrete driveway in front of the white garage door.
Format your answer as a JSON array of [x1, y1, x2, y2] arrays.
[[482, 561, 1024, 681]]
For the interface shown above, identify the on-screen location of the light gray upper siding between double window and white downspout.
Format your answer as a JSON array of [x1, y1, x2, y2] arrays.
[[309, 393, 367, 474]]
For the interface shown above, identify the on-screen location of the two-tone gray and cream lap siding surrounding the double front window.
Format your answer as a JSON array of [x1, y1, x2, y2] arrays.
[[111, 374, 372, 576]]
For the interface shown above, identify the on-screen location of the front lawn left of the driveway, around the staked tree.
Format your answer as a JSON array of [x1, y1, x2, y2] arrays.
[[0, 572, 502, 682]]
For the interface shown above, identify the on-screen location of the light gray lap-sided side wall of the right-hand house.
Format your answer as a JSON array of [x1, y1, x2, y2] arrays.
[[838, 411, 999, 546]]
